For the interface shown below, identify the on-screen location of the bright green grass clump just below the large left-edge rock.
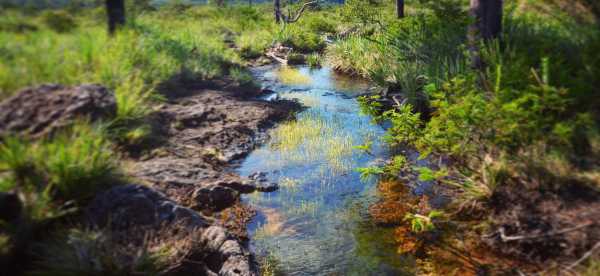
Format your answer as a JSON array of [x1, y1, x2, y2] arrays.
[[0, 123, 117, 216]]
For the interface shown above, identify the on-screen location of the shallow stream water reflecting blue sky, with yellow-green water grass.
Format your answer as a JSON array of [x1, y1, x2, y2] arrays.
[[238, 67, 414, 275]]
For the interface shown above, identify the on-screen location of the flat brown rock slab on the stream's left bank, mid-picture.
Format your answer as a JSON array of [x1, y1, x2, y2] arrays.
[[132, 90, 298, 214]]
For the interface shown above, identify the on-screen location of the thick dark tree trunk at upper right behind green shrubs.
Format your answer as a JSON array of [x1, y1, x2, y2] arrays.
[[469, 0, 503, 69]]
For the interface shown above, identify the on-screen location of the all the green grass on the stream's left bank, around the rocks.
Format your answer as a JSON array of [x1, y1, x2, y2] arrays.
[[0, 1, 342, 275]]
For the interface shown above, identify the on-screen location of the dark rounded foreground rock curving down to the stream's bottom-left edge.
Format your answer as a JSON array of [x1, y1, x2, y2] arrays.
[[86, 185, 258, 276]]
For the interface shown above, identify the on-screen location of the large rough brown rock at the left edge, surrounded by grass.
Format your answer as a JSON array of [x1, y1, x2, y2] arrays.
[[0, 84, 117, 138]]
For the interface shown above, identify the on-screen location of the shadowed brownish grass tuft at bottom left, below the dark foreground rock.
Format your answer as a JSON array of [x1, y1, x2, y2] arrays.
[[30, 225, 202, 275]]
